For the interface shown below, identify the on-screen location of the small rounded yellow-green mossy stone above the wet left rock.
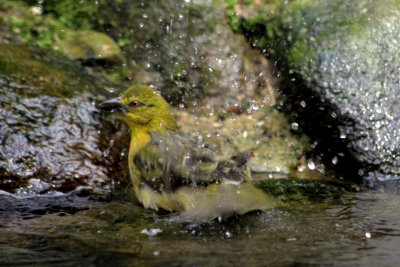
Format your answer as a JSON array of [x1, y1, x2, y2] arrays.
[[54, 30, 124, 65]]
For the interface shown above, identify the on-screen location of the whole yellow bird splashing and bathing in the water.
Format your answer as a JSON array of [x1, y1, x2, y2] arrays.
[[98, 85, 275, 221]]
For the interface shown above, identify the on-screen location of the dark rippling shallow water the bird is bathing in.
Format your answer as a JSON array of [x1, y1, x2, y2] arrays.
[[0, 181, 400, 266]]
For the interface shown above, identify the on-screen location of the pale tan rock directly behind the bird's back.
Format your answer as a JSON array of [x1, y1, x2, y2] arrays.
[[174, 103, 307, 175]]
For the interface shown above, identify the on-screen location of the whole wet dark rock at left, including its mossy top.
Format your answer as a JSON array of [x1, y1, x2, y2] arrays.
[[0, 45, 125, 193]]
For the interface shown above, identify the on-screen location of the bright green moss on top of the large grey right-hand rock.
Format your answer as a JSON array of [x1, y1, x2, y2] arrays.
[[226, 0, 398, 70]]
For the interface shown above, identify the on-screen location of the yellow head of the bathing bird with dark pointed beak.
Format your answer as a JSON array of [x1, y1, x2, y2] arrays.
[[98, 85, 177, 133]]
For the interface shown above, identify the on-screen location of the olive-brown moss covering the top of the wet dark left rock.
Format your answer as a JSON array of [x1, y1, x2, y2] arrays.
[[0, 45, 114, 98]]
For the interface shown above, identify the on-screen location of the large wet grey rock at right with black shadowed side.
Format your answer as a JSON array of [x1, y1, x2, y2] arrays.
[[228, 0, 400, 180]]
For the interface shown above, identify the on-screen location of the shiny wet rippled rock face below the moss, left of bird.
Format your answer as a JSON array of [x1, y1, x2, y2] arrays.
[[0, 89, 106, 190]]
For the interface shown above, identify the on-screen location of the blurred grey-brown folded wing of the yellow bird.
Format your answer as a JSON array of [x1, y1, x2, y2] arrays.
[[135, 130, 248, 191]]
